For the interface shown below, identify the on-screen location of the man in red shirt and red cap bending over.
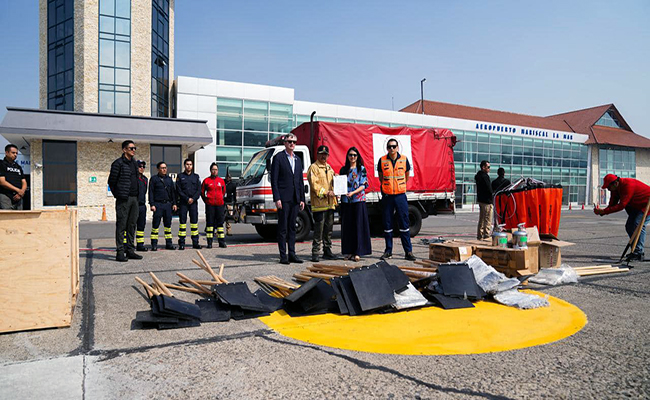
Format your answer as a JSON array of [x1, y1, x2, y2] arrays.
[[594, 174, 650, 261]]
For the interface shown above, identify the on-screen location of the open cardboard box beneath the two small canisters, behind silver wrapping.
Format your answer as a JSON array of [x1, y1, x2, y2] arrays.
[[474, 245, 539, 276]]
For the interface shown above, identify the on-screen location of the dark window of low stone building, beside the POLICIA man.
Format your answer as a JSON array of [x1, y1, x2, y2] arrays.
[[43, 140, 77, 206]]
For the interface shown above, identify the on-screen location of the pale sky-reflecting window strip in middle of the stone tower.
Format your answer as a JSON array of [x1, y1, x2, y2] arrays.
[[99, 0, 131, 115]]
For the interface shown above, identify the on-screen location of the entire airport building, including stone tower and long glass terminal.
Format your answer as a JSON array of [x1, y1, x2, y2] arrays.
[[0, 0, 650, 220]]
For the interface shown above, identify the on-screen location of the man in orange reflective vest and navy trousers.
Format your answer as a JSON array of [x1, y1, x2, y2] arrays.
[[377, 139, 415, 261]]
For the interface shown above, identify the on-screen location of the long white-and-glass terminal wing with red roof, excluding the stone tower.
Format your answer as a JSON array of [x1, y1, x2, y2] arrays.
[[175, 76, 650, 211]]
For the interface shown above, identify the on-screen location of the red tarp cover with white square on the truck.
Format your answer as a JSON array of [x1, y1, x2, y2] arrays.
[[292, 122, 456, 192]]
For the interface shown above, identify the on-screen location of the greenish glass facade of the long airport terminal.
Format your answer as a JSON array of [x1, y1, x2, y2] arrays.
[[216, 108, 588, 206]]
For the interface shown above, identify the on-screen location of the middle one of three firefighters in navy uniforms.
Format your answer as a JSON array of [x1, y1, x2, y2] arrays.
[[149, 161, 176, 251]]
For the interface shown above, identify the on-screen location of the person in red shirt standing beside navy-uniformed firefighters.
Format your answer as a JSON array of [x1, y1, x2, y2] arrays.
[[201, 163, 226, 249]]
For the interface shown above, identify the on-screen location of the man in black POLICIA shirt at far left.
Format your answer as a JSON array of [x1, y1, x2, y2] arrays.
[[0, 144, 27, 210]]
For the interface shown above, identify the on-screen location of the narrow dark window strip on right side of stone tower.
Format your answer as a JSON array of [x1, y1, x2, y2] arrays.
[[151, 0, 169, 117]]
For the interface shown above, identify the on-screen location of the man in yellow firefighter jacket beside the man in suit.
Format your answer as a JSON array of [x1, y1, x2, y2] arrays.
[[307, 145, 337, 262]]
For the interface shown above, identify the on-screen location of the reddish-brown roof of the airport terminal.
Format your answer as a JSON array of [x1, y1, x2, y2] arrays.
[[401, 100, 650, 148]]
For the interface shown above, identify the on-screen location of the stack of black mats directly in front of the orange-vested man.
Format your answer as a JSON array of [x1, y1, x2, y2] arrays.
[[326, 261, 409, 315]]
